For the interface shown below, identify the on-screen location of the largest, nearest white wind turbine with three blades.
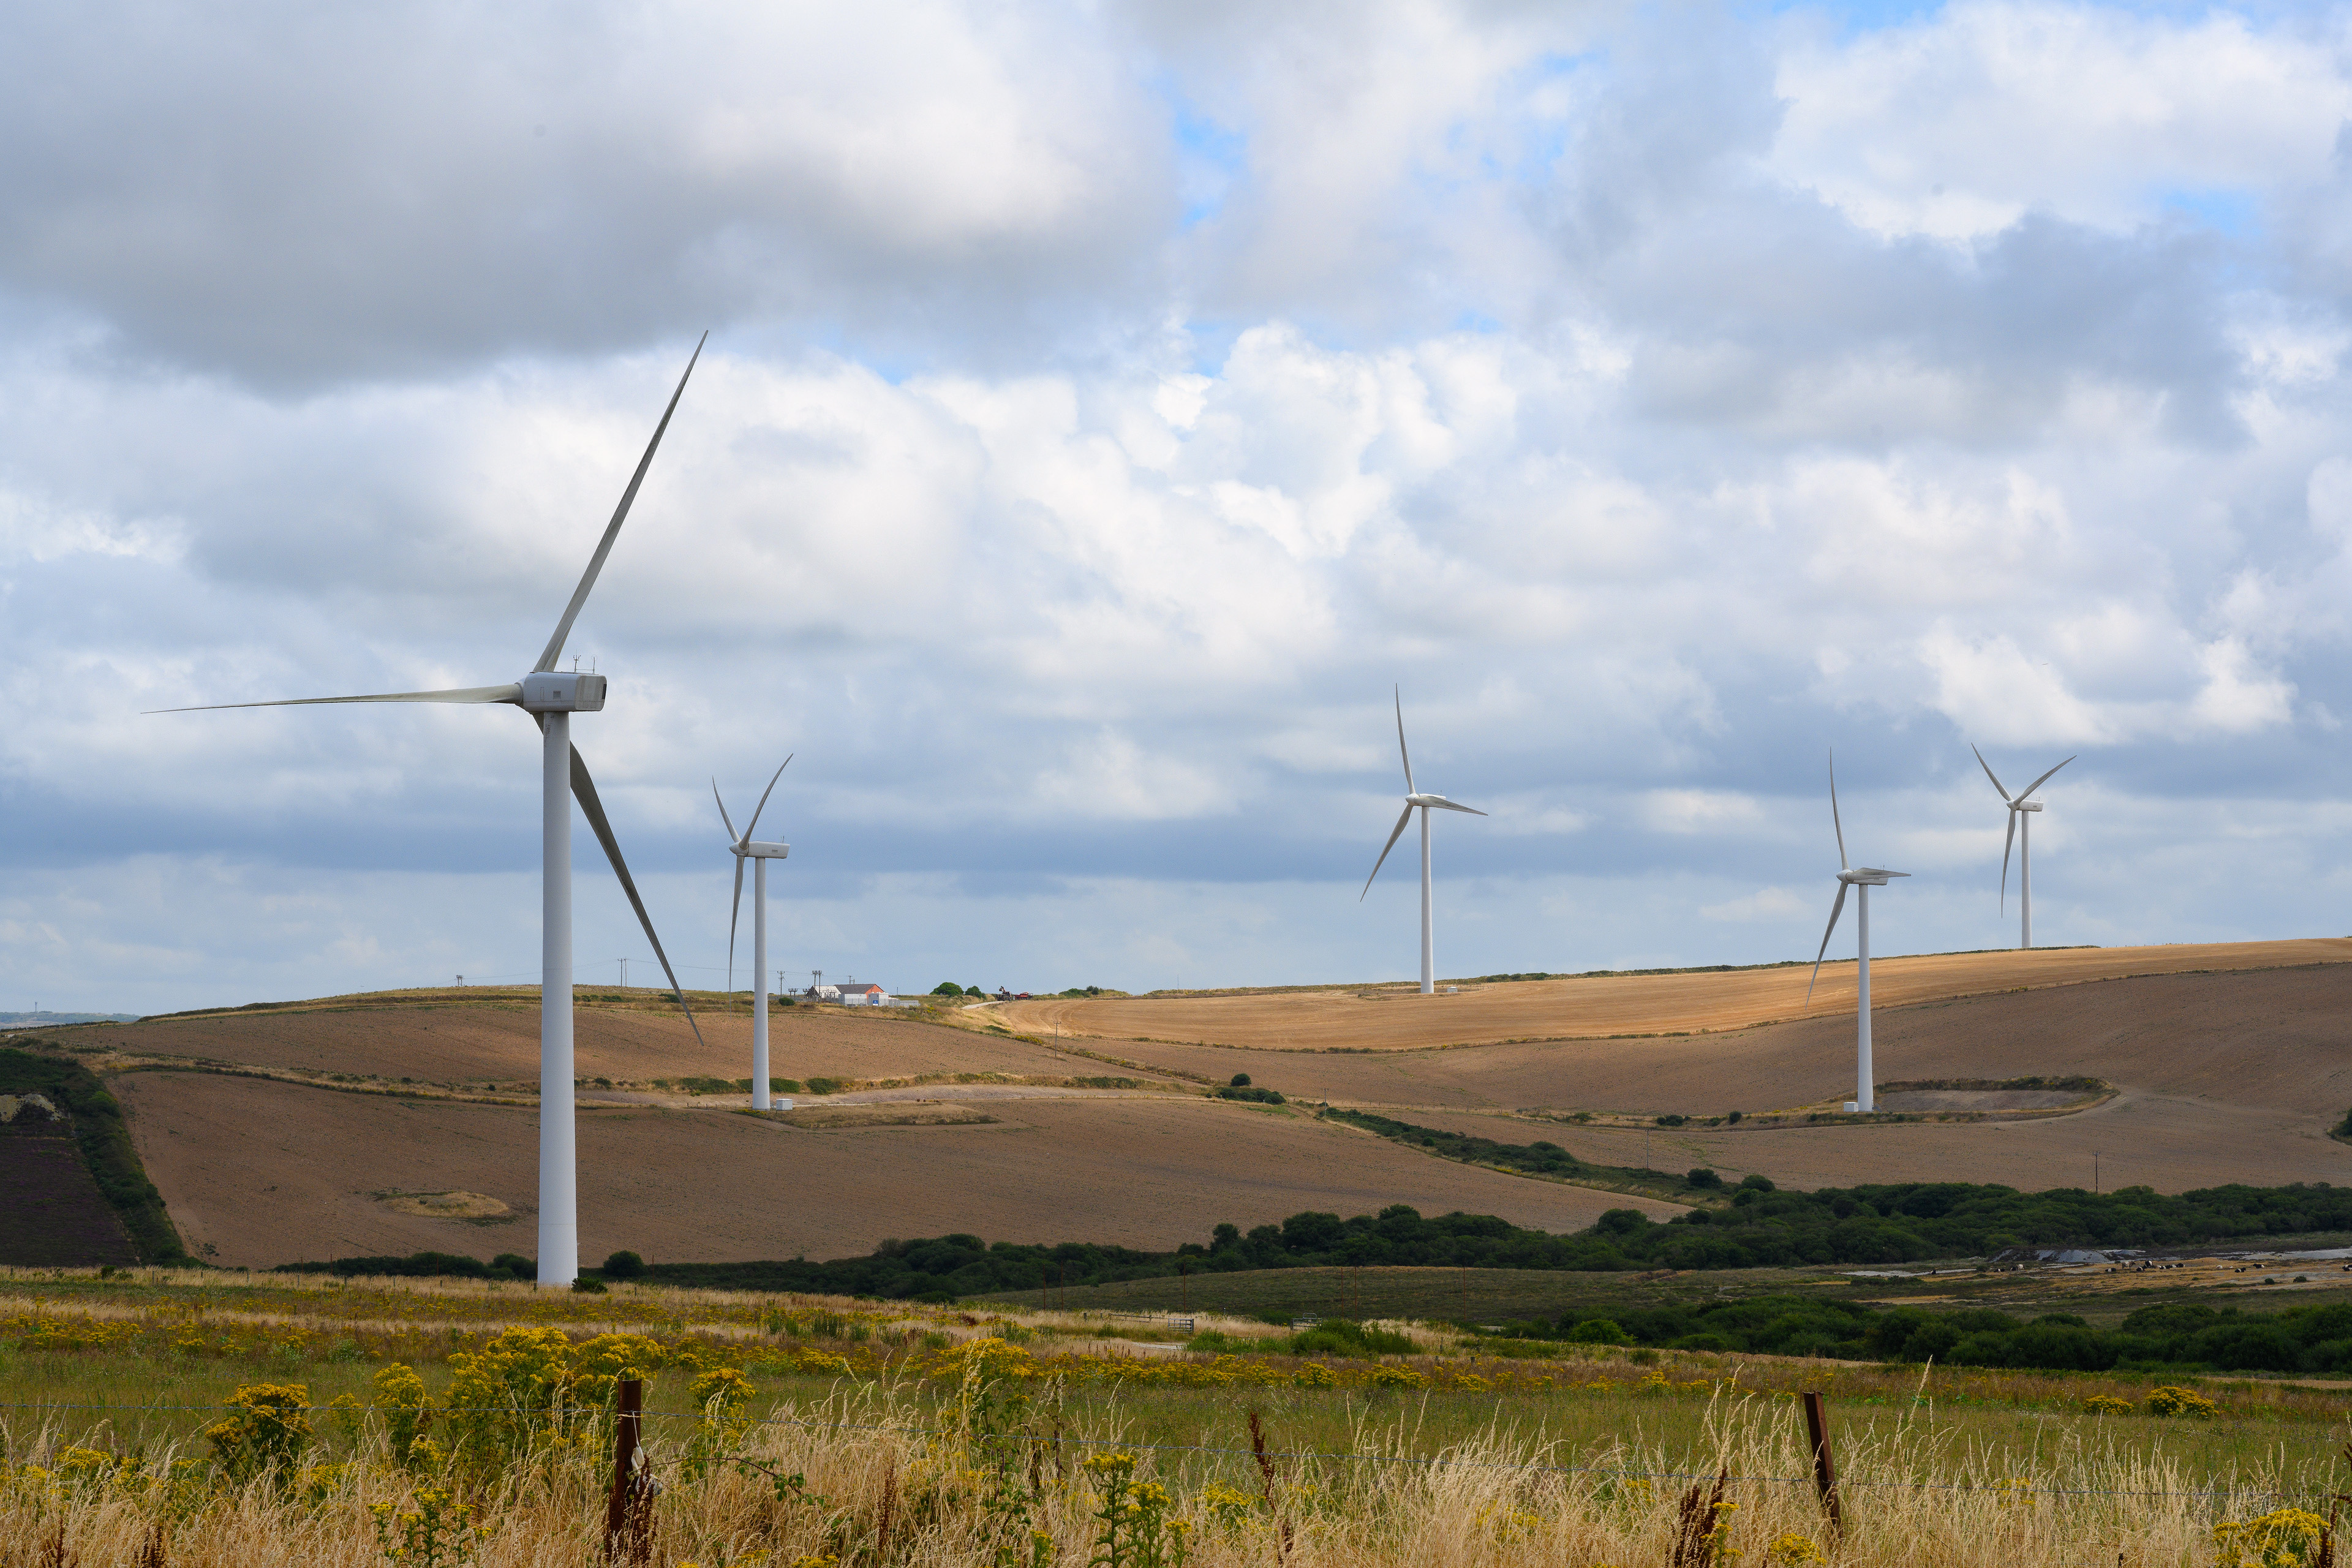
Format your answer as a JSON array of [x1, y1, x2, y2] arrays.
[[160, 331, 710, 1286]]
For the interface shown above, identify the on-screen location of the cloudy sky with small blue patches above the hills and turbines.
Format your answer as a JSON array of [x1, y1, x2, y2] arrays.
[[0, 0, 2352, 1011]]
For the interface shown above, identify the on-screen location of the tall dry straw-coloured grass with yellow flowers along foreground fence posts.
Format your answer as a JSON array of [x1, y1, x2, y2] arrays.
[[0, 1382, 2340, 1568]]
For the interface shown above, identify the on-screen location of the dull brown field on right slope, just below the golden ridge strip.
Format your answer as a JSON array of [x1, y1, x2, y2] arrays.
[[1063, 964, 2352, 1192]]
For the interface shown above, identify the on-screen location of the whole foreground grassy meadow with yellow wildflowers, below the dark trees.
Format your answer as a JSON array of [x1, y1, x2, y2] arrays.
[[0, 1270, 2352, 1568]]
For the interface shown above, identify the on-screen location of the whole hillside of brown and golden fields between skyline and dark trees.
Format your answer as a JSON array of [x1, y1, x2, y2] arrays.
[[9, 940, 2352, 1267]]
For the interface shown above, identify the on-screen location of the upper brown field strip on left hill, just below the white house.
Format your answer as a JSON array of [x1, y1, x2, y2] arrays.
[[56, 990, 1103, 1086]]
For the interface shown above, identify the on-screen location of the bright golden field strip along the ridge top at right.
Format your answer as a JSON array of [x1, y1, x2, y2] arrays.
[[995, 938, 2352, 1051]]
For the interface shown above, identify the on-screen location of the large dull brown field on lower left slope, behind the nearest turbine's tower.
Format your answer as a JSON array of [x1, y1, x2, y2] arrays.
[[113, 1072, 1675, 1267]]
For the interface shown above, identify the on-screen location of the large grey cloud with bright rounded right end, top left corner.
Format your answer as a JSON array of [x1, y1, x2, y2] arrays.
[[0, 0, 1176, 385]]
